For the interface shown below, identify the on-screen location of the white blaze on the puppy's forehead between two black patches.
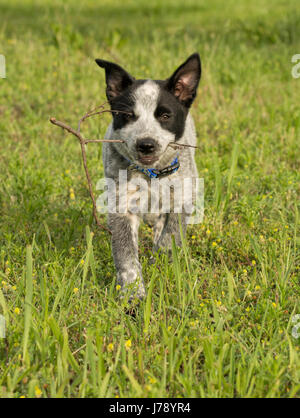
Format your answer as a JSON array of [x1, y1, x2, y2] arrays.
[[134, 80, 159, 117]]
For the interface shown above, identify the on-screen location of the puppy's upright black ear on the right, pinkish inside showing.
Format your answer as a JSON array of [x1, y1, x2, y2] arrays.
[[166, 53, 201, 107]]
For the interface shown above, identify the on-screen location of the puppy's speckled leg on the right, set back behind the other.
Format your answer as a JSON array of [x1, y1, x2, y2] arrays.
[[154, 213, 186, 255]]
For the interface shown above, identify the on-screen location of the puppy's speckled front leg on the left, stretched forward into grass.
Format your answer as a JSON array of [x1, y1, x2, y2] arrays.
[[108, 213, 146, 300]]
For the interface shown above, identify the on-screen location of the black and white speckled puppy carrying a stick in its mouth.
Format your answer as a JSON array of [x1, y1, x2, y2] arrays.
[[96, 53, 201, 298]]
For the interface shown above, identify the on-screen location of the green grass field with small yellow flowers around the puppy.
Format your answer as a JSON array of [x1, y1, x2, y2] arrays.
[[0, 0, 300, 398]]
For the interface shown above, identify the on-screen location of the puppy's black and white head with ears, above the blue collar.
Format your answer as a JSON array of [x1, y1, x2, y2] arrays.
[[96, 54, 201, 167]]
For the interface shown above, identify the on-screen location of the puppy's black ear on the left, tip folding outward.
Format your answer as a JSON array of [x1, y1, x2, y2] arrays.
[[95, 59, 134, 101]]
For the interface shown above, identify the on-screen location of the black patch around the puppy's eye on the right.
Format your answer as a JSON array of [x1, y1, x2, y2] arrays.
[[154, 80, 188, 141]]
